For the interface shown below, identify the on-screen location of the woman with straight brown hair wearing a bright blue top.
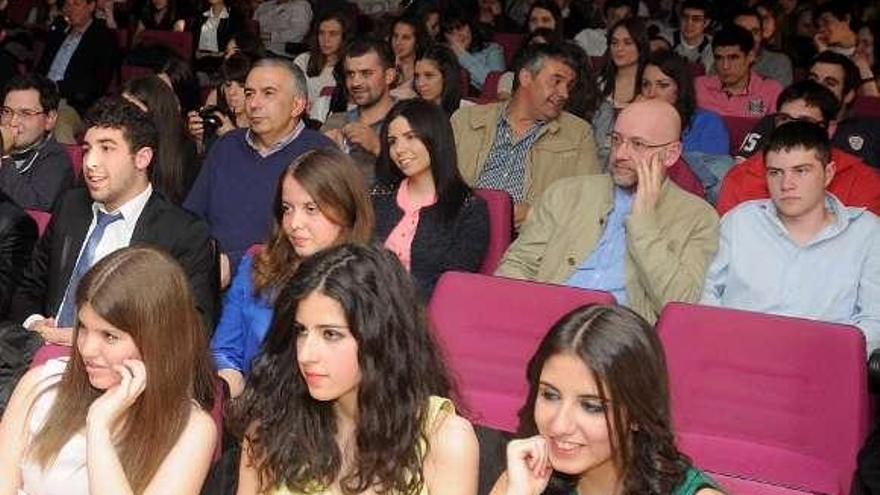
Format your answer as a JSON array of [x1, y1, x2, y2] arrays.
[[211, 149, 373, 397]]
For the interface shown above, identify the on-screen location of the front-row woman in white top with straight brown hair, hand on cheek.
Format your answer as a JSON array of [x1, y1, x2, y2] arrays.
[[0, 247, 217, 495]]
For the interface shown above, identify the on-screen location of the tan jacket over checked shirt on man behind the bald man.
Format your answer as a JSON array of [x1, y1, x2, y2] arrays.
[[452, 103, 601, 203]]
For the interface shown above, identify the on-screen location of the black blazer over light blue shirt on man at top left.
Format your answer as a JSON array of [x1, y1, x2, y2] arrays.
[[37, 19, 119, 116]]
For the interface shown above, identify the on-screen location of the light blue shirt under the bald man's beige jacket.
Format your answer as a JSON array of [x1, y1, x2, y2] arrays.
[[566, 186, 633, 304]]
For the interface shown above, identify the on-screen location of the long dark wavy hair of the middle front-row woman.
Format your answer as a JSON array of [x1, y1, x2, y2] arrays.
[[231, 244, 452, 494]]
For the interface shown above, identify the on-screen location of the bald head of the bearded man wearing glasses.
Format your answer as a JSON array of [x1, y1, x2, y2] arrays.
[[608, 99, 681, 188]]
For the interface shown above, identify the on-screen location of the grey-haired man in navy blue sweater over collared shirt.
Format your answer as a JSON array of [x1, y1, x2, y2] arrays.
[[184, 58, 333, 287]]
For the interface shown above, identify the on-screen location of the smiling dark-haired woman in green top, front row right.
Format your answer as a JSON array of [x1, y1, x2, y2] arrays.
[[492, 305, 722, 495]]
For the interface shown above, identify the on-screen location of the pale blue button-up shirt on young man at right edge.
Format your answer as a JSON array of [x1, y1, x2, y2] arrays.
[[702, 193, 880, 354]]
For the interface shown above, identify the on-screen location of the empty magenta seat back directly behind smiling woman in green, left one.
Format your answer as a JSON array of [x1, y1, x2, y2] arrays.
[[429, 272, 614, 431]]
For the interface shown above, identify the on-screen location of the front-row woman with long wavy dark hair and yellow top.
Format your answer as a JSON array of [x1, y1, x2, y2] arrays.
[[233, 244, 479, 495]]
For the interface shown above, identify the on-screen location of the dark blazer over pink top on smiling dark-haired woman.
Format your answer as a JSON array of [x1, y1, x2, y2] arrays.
[[370, 184, 489, 299]]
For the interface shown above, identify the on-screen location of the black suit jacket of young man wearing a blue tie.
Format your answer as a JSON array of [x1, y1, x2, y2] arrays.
[[10, 188, 219, 331]]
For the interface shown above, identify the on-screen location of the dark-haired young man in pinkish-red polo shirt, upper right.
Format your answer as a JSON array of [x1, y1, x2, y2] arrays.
[[694, 24, 782, 117]]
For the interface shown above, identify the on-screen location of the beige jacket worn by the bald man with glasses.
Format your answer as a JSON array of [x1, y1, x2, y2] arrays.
[[496, 175, 718, 323]]
